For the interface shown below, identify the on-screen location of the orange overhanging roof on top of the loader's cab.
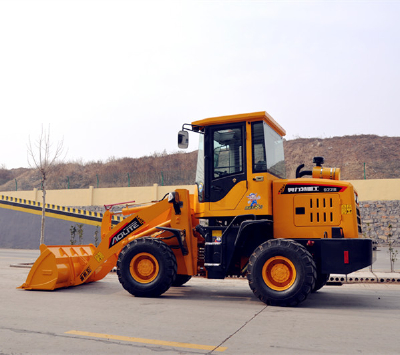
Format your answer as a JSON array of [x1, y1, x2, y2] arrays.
[[192, 111, 286, 137]]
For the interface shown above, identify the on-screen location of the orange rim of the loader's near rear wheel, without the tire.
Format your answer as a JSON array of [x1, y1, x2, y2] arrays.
[[262, 256, 296, 291]]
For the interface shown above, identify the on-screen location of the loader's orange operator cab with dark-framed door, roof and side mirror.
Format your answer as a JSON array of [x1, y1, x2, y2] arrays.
[[178, 112, 286, 218]]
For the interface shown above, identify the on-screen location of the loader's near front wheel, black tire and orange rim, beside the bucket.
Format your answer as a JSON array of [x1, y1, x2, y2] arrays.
[[117, 238, 177, 297]]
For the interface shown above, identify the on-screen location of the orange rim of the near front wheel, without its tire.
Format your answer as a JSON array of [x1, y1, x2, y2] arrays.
[[130, 253, 160, 284]]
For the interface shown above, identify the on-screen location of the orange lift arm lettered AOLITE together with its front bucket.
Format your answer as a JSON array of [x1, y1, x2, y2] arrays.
[[20, 190, 197, 290]]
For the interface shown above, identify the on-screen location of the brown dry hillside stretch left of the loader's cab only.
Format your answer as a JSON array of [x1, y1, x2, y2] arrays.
[[0, 152, 197, 191]]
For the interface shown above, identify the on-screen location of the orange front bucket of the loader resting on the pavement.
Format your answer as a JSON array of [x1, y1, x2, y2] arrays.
[[19, 244, 109, 290]]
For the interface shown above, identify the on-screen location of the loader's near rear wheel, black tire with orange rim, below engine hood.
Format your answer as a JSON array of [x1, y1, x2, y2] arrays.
[[247, 239, 317, 306]]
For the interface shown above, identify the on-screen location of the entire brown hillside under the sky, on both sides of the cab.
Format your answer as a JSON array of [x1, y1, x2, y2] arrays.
[[0, 135, 400, 191]]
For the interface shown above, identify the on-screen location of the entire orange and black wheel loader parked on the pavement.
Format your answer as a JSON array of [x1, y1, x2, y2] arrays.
[[20, 112, 375, 306]]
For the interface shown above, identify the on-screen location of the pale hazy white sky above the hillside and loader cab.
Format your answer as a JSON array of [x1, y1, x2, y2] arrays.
[[0, 0, 400, 169]]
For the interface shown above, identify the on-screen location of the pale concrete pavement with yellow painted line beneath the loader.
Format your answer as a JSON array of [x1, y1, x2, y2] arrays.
[[0, 249, 400, 355]]
